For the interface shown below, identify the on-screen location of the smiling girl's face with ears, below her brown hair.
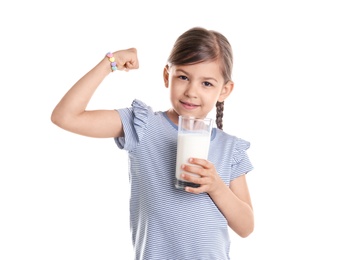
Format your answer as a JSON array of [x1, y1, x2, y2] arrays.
[[164, 61, 233, 124]]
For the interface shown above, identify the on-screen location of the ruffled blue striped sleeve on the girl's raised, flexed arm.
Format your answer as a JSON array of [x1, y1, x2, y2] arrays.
[[114, 99, 150, 150]]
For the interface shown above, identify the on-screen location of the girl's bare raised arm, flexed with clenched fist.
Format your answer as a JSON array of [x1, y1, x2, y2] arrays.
[[51, 48, 139, 137]]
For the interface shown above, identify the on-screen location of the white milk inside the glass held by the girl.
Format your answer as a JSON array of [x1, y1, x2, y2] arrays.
[[176, 133, 211, 180]]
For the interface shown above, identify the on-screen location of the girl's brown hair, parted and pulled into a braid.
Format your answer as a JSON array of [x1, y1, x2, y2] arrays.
[[167, 27, 233, 129]]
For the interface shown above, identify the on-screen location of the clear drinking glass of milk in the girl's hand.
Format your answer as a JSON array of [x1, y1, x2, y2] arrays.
[[175, 116, 213, 189]]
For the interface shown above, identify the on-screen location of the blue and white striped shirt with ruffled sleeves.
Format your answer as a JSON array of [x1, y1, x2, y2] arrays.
[[114, 100, 253, 260]]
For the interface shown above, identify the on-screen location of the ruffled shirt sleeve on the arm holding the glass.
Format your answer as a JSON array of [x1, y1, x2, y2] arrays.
[[231, 138, 253, 180]]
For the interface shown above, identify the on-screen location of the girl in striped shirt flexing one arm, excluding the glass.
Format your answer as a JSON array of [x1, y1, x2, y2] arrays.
[[51, 27, 254, 260]]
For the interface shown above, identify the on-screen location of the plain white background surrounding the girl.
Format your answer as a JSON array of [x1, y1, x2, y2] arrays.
[[0, 0, 357, 260]]
